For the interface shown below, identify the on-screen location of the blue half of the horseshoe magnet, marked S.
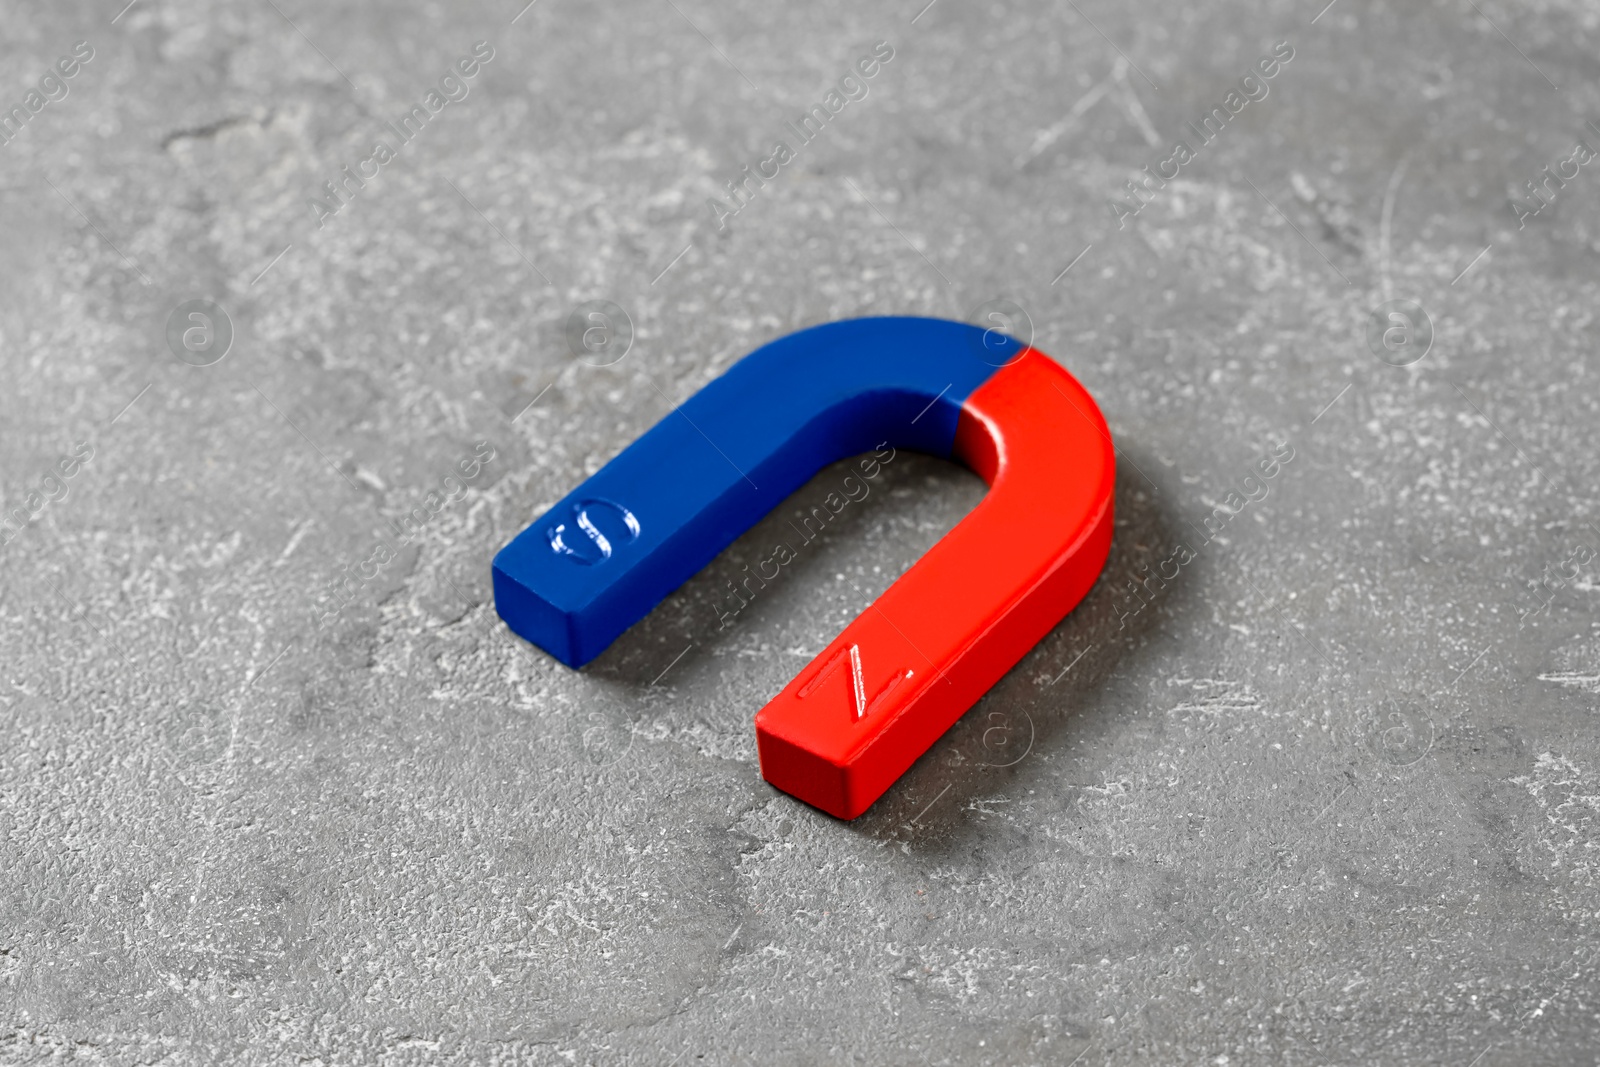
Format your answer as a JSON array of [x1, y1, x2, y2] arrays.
[[494, 318, 1022, 667]]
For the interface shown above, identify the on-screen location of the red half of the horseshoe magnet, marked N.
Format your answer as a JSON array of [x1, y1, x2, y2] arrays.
[[755, 349, 1115, 819]]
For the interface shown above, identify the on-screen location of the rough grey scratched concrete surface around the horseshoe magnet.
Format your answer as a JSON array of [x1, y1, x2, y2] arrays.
[[0, 0, 1600, 1067]]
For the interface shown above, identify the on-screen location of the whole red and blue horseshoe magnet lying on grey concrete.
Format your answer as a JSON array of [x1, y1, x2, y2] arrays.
[[494, 318, 1115, 819]]
